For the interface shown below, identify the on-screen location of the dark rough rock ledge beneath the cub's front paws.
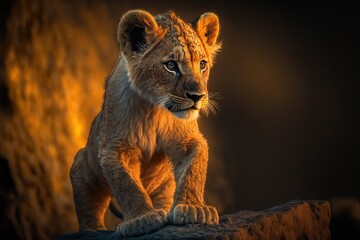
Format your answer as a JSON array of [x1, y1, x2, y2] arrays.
[[56, 200, 330, 240]]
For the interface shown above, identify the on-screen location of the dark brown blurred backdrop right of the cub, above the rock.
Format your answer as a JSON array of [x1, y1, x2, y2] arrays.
[[119, 1, 360, 212]]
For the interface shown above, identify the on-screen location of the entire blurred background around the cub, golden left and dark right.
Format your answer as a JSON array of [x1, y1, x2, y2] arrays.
[[0, 0, 360, 239]]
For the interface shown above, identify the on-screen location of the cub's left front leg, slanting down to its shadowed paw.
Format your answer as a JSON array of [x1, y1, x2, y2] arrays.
[[101, 149, 168, 237]]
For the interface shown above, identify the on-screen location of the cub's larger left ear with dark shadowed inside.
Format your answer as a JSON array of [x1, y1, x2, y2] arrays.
[[117, 10, 158, 55]]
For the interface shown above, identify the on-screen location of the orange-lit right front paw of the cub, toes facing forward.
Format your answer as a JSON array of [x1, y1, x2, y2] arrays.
[[169, 204, 219, 224]]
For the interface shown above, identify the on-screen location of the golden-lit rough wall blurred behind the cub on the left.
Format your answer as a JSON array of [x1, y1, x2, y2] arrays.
[[0, 1, 117, 236]]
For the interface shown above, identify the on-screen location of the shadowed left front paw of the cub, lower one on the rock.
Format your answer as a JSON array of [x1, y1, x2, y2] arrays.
[[117, 209, 168, 237]]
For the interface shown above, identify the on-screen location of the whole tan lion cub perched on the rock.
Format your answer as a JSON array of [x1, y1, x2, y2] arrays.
[[70, 10, 220, 236]]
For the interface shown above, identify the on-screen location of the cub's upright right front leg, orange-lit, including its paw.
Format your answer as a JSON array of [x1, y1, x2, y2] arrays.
[[169, 138, 219, 224]]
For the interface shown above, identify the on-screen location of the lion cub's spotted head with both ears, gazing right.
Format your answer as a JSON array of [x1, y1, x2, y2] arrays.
[[117, 10, 220, 119]]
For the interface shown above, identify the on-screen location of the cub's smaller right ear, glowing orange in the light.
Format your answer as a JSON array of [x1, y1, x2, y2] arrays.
[[191, 12, 221, 62]]
